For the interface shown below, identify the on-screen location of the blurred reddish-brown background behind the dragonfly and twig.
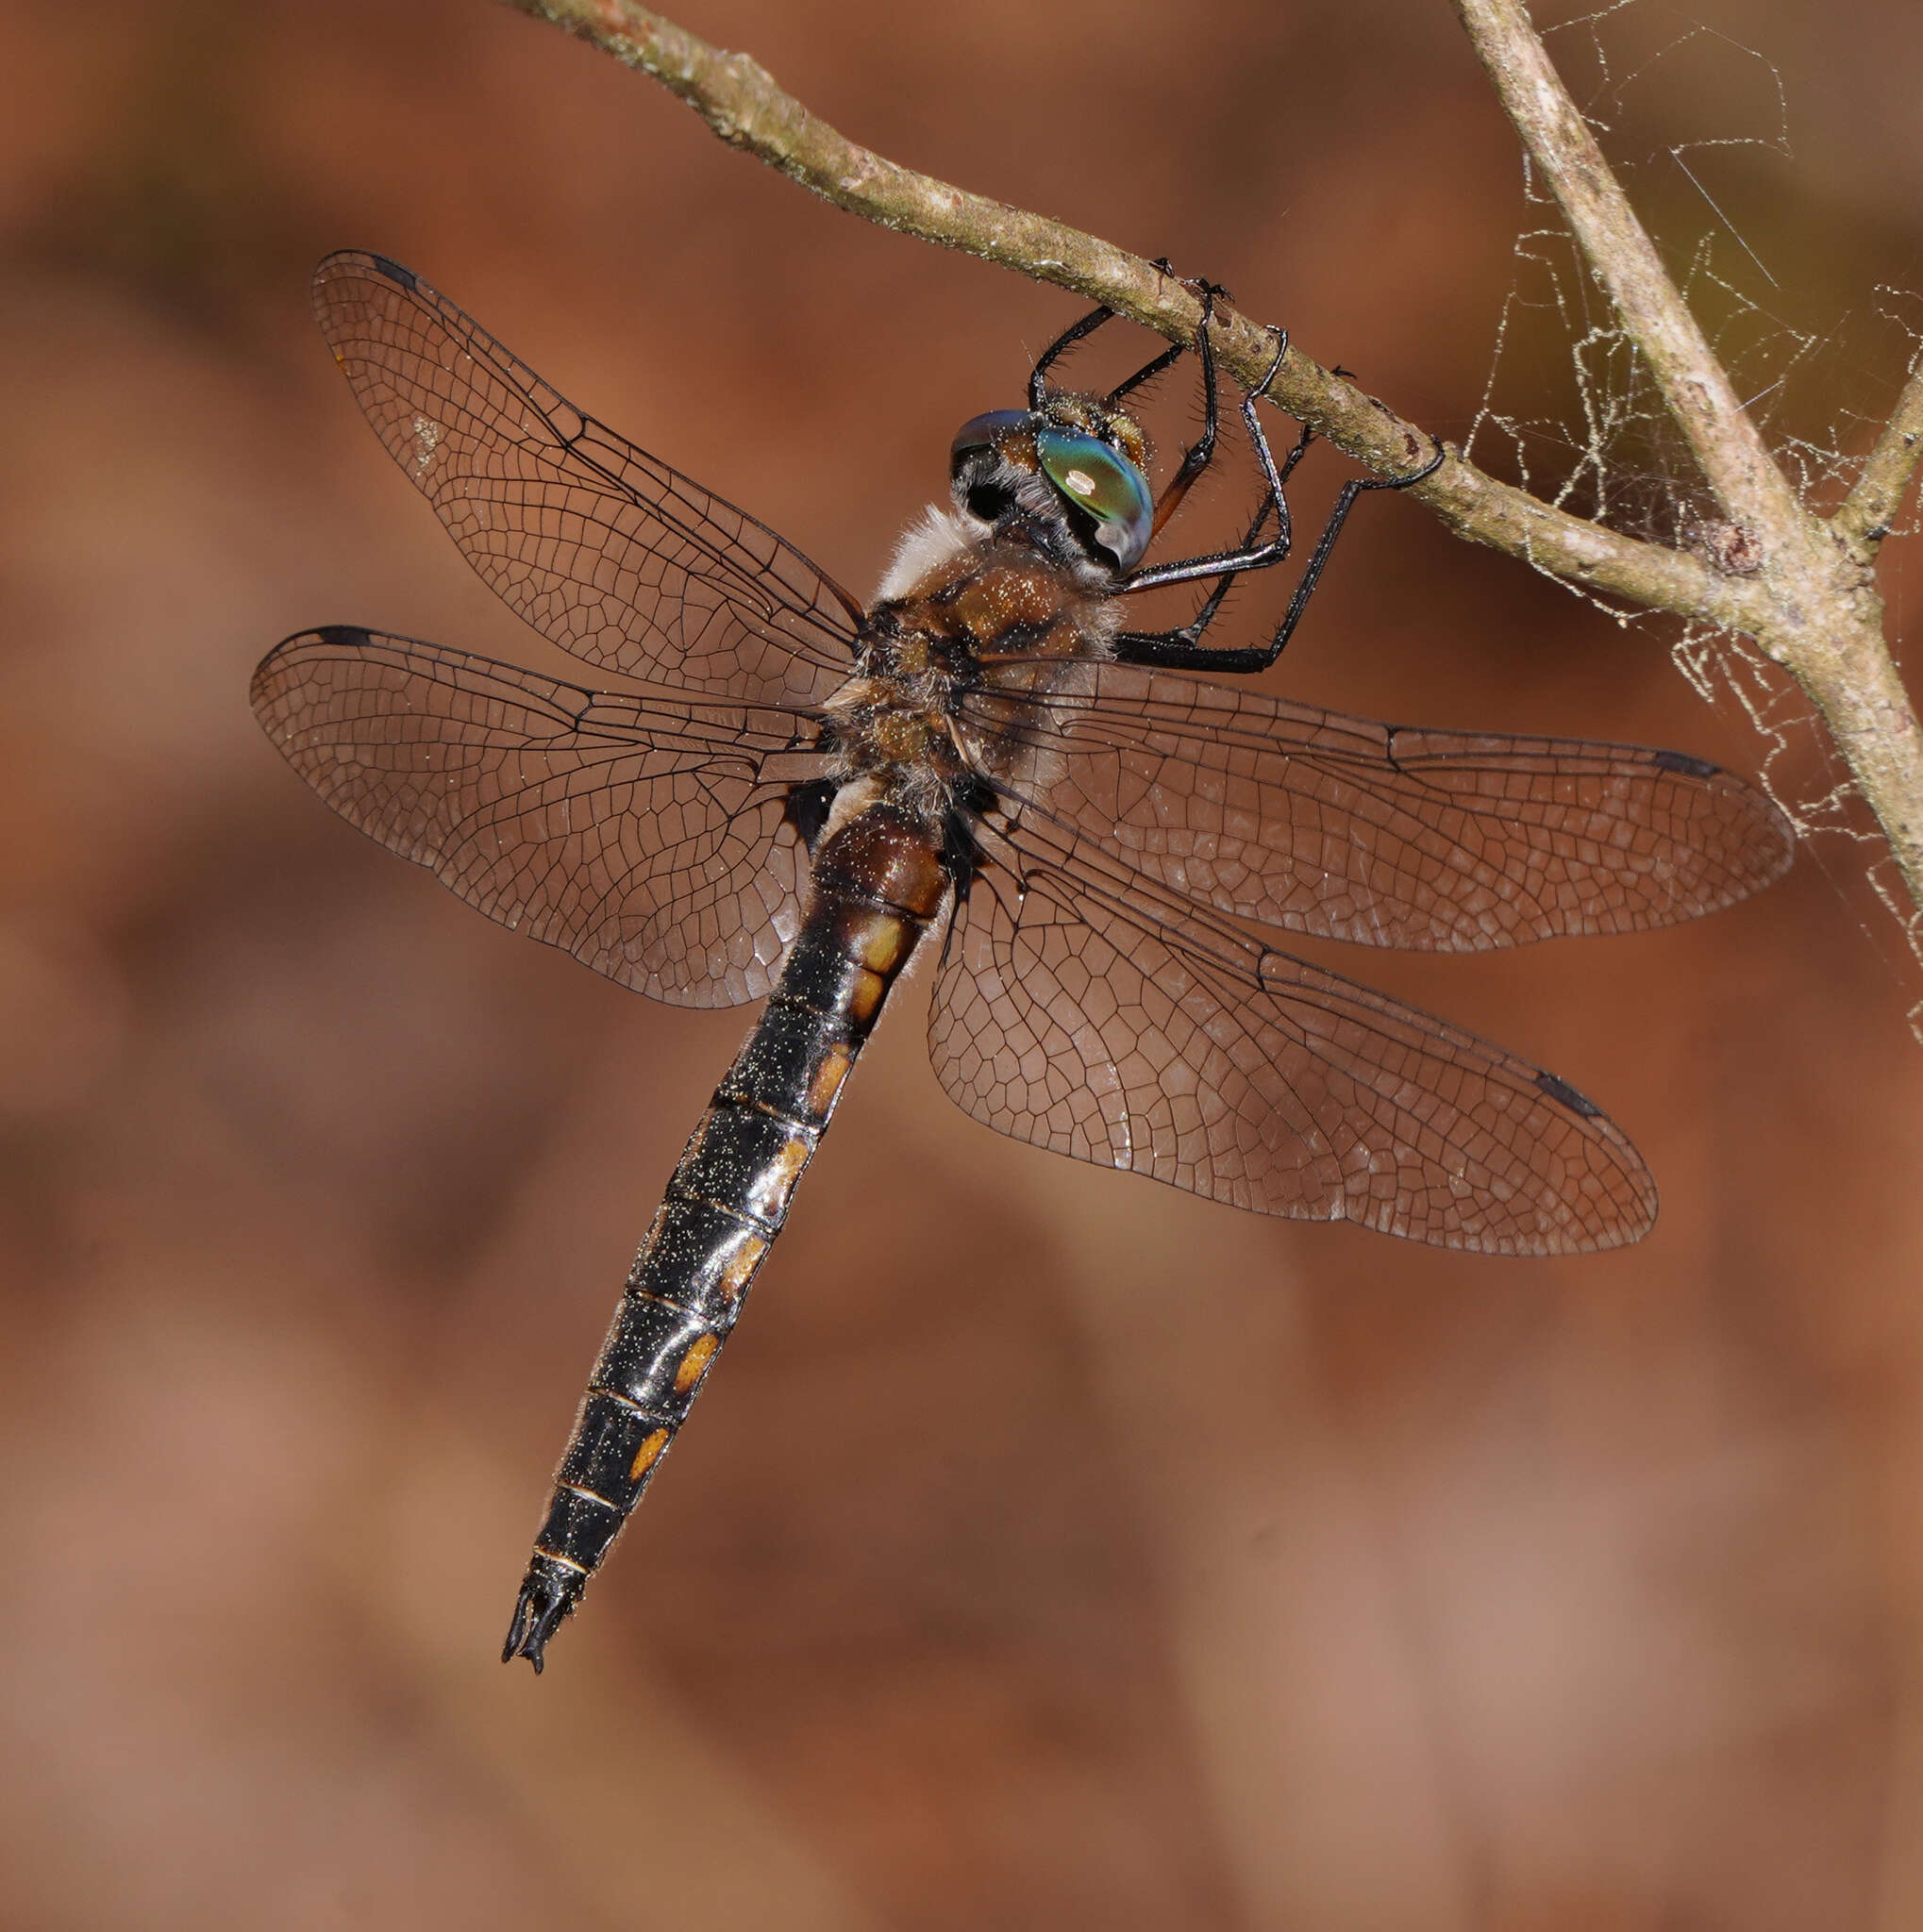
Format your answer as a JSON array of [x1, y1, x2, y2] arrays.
[[0, 0, 1923, 1932]]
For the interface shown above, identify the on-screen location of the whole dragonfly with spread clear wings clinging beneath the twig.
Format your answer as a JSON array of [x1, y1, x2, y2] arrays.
[[251, 253, 1792, 1672]]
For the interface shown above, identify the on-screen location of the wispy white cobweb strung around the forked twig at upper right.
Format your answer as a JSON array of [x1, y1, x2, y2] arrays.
[[1465, 0, 1923, 1041]]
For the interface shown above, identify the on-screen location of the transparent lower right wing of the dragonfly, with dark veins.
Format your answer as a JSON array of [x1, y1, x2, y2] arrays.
[[929, 824, 1656, 1254]]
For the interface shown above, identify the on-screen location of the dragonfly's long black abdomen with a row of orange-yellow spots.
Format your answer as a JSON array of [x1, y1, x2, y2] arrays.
[[503, 806, 949, 1669]]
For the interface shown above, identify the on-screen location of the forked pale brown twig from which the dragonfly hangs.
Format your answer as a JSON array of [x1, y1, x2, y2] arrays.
[[507, 0, 1923, 927]]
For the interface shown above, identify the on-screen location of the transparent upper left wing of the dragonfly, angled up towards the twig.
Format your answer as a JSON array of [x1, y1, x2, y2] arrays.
[[313, 253, 860, 703]]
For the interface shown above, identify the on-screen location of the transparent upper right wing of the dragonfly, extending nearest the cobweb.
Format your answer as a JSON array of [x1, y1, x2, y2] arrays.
[[964, 665, 1794, 953]]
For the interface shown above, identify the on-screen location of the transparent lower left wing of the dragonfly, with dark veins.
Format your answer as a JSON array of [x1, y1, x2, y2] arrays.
[[253, 626, 819, 1007]]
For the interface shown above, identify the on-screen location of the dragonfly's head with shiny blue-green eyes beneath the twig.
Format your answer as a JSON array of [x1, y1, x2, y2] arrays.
[[949, 394, 1156, 575]]
